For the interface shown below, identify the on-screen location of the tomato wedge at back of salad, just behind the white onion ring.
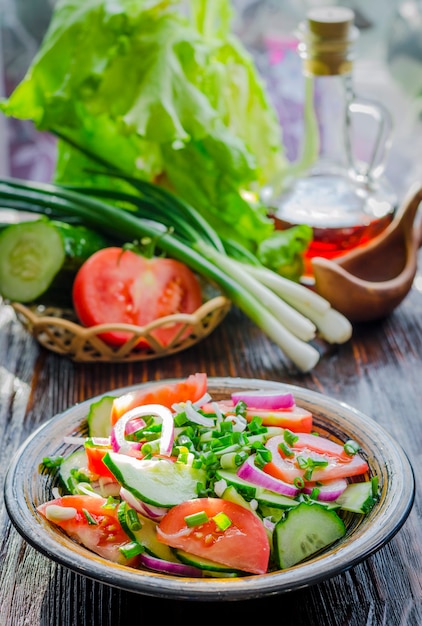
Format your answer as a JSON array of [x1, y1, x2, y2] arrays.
[[111, 373, 208, 425]]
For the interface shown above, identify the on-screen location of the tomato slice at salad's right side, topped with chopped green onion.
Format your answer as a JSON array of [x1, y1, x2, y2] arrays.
[[262, 433, 369, 483]]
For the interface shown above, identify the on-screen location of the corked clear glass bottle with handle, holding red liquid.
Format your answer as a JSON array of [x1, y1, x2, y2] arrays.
[[263, 6, 397, 276]]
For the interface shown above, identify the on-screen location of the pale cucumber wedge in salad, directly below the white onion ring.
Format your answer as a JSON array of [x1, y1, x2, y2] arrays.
[[103, 452, 206, 508]]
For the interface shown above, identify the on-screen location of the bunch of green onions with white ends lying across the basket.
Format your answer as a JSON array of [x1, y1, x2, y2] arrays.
[[0, 174, 351, 372]]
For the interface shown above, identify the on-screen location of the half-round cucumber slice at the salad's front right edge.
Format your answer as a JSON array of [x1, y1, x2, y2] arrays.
[[274, 502, 346, 569]]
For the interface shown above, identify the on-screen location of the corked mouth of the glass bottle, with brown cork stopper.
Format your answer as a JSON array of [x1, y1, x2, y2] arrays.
[[298, 6, 358, 76]]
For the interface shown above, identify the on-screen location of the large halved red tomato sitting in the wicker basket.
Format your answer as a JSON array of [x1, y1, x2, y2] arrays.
[[73, 247, 202, 346]]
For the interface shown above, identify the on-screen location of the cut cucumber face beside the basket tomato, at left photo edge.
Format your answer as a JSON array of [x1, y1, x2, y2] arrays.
[[0, 219, 66, 302]]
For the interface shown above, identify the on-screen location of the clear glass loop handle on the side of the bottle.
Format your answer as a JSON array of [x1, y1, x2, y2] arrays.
[[346, 98, 393, 184]]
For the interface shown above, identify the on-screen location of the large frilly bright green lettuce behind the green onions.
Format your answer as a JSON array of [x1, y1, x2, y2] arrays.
[[0, 0, 310, 276]]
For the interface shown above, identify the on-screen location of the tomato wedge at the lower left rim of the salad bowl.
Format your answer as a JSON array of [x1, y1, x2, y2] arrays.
[[37, 495, 138, 565]]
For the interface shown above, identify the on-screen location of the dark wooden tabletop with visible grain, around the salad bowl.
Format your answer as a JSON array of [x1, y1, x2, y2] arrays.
[[0, 266, 422, 626]]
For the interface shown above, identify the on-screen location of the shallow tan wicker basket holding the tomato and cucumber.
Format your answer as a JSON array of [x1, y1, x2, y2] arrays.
[[11, 295, 231, 362]]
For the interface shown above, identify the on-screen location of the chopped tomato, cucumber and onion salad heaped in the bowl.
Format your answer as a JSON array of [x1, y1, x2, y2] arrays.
[[38, 373, 378, 577]]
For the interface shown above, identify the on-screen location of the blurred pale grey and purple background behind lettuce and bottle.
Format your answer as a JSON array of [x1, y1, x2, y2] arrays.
[[0, 0, 422, 196]]
